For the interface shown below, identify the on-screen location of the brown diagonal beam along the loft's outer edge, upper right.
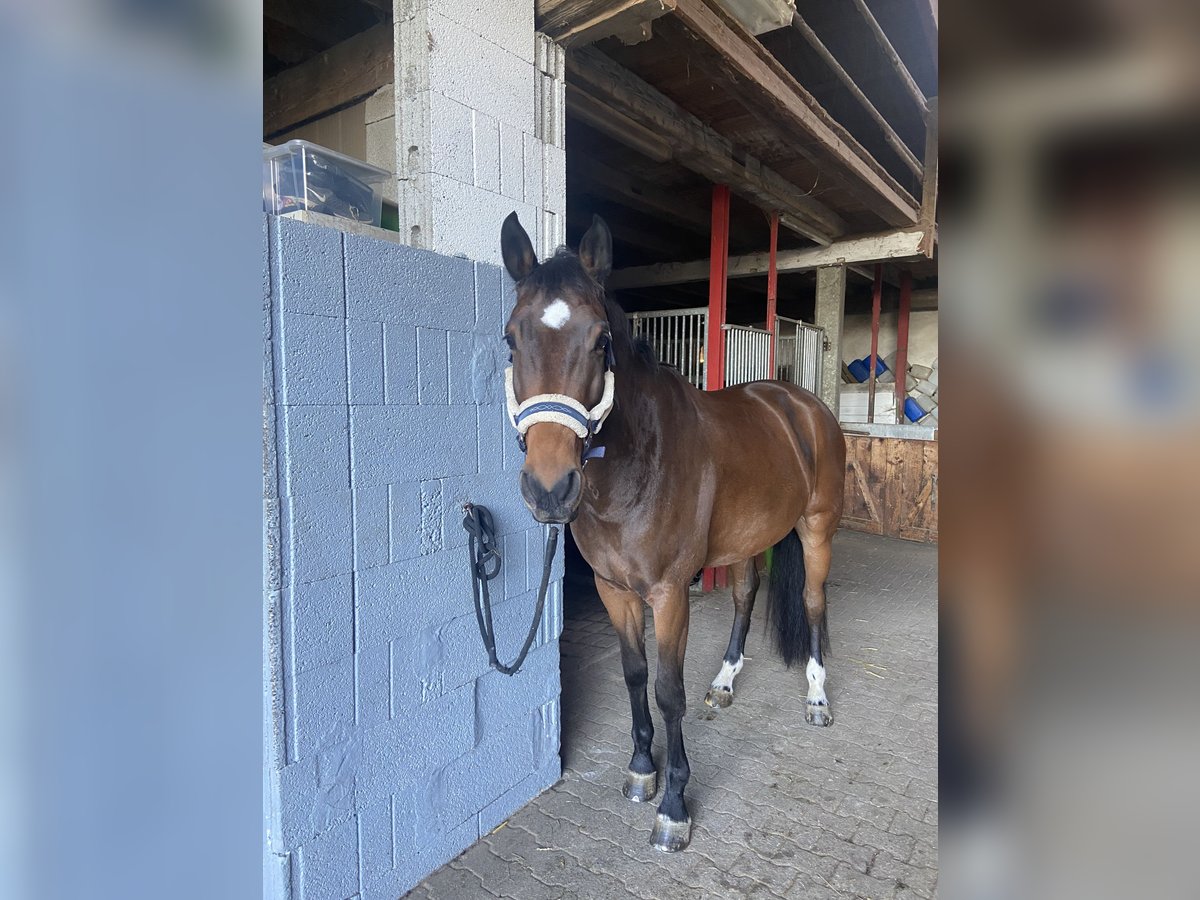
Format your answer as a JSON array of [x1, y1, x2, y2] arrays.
[[676, 0, 924, 226]]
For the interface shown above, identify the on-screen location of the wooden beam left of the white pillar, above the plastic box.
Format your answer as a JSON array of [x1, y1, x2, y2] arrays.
[[263, 22, 396, 138]]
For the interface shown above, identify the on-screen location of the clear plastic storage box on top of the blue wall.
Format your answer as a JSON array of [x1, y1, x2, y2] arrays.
[[263, 140, 389, 227]]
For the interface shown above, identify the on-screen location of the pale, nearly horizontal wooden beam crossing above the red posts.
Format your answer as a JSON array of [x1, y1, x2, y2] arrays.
[[608, 228, 925, 289]]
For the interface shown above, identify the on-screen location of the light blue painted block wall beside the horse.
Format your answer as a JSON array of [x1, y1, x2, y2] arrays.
[[263, 216, 563, 900]]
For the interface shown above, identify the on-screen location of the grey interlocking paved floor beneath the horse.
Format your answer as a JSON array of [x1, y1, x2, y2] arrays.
[[410, 532, 937, 900]]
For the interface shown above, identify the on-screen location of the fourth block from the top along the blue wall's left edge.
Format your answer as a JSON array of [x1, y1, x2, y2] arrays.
[[284, 491, 353, 584]]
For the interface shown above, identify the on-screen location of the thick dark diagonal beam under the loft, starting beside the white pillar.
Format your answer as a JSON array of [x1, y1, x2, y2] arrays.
[[566, 47, 847, 244]]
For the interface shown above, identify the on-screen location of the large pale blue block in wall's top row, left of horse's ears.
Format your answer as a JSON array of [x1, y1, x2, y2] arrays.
[[346, 232, 472, 331]]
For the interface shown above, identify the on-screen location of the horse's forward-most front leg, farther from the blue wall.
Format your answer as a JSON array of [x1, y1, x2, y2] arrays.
[[649, 584, 691, 852]]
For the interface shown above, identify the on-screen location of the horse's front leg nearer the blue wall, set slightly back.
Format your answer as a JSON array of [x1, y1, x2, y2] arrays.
[[596, 576, 659, 802]]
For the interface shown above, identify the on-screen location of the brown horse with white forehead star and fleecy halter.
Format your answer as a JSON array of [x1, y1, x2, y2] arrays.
[[500, 212, 846, 851]]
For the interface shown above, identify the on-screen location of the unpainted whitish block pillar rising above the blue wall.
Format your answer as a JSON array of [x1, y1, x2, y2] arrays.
[[395, 0, 566, 263]]
